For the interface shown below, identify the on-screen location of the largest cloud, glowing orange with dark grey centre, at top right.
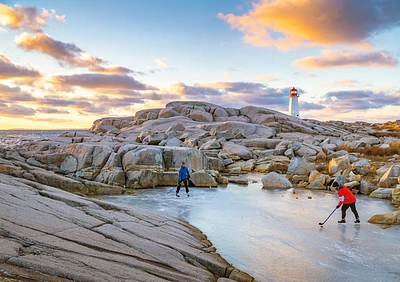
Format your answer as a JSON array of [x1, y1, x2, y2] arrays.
[[218, 0, 400, 49]]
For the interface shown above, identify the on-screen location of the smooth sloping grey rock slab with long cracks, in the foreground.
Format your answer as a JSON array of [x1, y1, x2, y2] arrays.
[[0, 174, 255, 281]]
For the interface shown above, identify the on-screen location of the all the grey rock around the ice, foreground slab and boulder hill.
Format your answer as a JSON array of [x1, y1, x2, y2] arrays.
[[0, 102, 400, 281]]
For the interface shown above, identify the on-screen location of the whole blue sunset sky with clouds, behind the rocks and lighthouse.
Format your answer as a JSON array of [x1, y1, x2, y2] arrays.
[[0, 0, 400, 129]]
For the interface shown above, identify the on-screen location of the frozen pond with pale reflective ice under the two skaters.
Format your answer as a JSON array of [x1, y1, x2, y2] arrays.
[[102, 180, 400, 281]]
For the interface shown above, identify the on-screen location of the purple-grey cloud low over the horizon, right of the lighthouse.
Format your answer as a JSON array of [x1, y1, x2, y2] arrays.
[[323, 90, 400, 113]]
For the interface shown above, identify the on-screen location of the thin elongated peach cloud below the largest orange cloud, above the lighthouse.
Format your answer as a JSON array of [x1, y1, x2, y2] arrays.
[[293, 50, 398, 69]]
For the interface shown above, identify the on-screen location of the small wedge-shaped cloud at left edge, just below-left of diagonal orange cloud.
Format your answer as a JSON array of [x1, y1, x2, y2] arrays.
[[0, 53, 41, 80]]
